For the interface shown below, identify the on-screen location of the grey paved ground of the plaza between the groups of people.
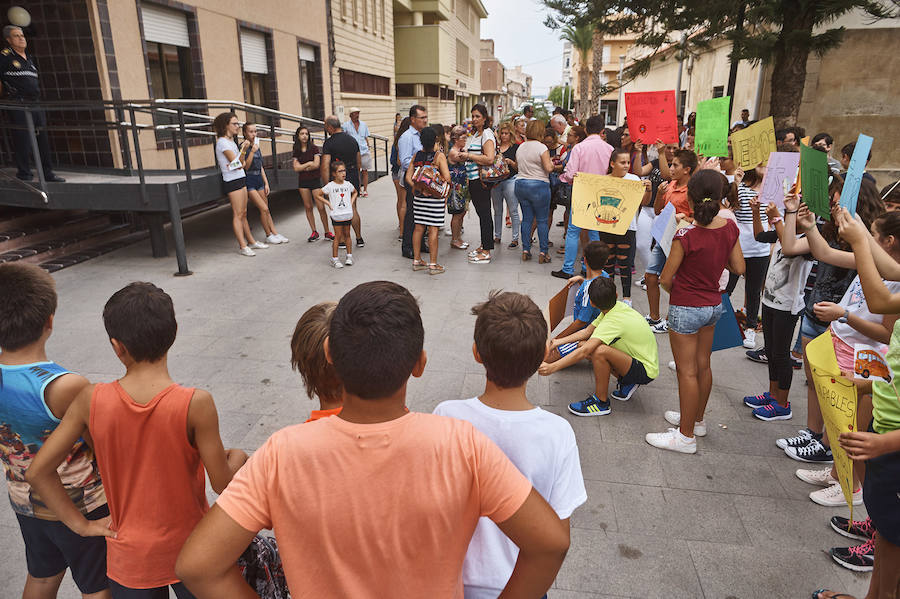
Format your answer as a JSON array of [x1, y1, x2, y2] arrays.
[[0, 178, 868, 599]]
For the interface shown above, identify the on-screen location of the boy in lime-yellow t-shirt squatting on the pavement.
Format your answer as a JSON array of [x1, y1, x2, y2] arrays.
[[538, 278, 659, 416]]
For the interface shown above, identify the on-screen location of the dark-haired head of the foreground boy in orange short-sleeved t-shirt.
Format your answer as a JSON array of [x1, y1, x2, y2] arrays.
[[328, 282, 425, 399]]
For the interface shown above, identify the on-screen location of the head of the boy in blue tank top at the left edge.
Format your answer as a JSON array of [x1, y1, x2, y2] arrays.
[[0, 262, 56, 351]]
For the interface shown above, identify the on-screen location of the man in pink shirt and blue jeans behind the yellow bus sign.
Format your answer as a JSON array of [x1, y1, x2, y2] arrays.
[[550, 115, 613, 279]]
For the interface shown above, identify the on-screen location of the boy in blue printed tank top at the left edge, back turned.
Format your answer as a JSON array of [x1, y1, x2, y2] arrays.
[[0, 262, 110, 599]]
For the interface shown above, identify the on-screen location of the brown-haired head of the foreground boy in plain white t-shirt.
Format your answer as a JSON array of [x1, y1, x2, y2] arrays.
[[472, 291, 547, 389]]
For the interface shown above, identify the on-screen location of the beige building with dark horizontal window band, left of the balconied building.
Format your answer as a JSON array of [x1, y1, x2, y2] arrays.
[[331, 0, 397, 137]]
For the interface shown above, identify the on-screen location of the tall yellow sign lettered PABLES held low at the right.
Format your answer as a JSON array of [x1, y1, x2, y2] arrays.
[[806, 331, 856, 520]]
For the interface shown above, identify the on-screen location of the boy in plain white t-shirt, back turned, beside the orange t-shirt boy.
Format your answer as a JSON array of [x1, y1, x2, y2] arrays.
[[434, 292, 587, 599]]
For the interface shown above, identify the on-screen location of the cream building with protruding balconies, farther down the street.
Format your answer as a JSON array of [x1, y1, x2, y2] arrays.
[[393, 0, 487, 125]]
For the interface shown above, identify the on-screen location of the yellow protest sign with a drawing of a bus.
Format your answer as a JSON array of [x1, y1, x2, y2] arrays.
[[572, 173, 644, 235]]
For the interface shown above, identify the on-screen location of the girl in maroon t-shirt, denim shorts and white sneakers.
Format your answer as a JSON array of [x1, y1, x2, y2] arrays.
[[646, 170, 744, 453]]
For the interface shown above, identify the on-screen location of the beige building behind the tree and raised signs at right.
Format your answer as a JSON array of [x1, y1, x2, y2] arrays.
[[625, 8, 900, 185]]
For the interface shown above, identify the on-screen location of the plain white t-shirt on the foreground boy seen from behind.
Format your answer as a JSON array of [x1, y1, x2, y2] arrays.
[[434, 397, 587, 599]]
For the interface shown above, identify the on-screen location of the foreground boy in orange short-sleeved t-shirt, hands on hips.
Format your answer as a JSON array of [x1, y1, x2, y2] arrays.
[[176, 281, 569, 599]]
